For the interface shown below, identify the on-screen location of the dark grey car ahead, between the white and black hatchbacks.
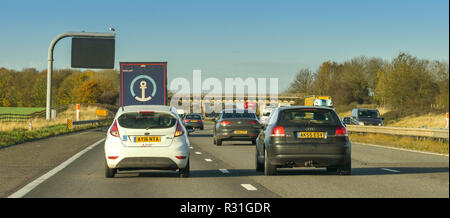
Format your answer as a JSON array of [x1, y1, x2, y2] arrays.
[[213, 109, 261, 146]]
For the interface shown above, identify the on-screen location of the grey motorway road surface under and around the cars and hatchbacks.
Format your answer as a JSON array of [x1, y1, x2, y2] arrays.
[[0, 124, 449, 198]]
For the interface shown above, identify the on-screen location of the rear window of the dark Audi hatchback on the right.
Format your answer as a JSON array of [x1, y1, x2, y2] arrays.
[[278, 109, 340, 126]]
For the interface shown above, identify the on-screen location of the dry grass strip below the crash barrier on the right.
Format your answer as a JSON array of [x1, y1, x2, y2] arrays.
[[349, 133, 449, 154]]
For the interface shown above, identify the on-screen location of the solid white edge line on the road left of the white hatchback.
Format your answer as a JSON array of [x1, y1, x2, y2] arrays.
[[8, 139, 105, 198]]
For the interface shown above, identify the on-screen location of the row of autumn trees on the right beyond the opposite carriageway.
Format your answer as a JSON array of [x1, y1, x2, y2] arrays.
[[287, 53, 449, 111]]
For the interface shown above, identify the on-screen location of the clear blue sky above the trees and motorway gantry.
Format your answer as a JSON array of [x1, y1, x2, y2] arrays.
[[0, 0, 449, 91]]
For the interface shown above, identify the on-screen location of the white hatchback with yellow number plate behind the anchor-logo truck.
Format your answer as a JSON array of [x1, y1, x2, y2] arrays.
[[105, 105, 190, 178]]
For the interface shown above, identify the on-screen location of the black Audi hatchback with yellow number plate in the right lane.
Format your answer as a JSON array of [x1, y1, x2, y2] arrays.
[[256, 106, 351, 175]]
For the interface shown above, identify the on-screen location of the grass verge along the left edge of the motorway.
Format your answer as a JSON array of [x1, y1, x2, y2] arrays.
[[0, 122, 109, 148]]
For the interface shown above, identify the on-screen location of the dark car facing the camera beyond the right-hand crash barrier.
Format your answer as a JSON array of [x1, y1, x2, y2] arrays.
[[351, 108, 384, 126]]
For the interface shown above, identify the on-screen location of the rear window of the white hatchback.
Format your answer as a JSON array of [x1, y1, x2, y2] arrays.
[[117, 112, 177, 129]]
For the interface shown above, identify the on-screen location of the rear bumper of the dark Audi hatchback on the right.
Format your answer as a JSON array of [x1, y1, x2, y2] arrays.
[[268, 144, 350, 167]]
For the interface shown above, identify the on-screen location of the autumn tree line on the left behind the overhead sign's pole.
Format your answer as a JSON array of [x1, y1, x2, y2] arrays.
[[0, 68, 120, 107]]
